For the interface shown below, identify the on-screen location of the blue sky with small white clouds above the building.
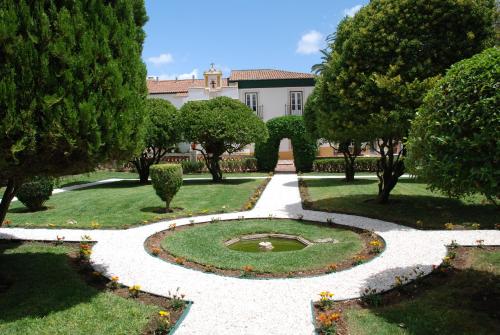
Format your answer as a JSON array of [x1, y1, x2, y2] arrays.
[[143, 0, 368, 79]]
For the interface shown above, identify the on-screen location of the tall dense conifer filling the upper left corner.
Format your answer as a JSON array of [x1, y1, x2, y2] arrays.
[[0, 0, 147, 224]]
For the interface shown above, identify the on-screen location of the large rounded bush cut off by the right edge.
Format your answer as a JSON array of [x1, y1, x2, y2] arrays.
[[409, 48, 500, 201]]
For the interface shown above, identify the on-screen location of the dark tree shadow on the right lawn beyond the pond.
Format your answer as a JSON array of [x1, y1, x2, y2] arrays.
[[310, 194, 499, 229]]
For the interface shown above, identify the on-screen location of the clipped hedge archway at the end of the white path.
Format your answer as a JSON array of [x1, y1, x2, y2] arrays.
[[255, 115, 318, 172]]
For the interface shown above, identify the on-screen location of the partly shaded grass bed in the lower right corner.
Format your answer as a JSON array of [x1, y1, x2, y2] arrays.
[[345, 249, 500, 335]]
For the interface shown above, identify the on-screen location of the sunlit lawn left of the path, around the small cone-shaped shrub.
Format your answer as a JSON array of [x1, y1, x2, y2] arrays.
[[7, 179, 263, 228]]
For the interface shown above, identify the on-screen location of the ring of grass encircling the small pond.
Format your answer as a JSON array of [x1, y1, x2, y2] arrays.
[[162, 219, 363, 273]]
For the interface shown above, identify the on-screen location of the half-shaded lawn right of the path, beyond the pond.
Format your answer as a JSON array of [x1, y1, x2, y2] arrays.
[[303, 179, 500, 229]]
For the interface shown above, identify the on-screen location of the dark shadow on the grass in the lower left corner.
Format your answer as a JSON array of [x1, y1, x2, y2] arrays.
[[0, 241, 99, 323]]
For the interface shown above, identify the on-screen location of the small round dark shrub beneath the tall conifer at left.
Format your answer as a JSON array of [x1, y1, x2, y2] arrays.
[[16, 176, 54, 211]]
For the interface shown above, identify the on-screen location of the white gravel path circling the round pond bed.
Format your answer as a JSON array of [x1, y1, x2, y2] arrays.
[[0, 174, 500, 335]]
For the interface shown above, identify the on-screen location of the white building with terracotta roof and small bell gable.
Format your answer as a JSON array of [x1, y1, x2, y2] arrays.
[[147, 64, 324, 159]]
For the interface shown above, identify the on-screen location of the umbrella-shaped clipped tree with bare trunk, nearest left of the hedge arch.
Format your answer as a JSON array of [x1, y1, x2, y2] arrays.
[[180, 97, 268, 182]]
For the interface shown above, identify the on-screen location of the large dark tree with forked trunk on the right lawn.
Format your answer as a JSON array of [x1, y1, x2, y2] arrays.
[[324, 0, 495, 203]]
